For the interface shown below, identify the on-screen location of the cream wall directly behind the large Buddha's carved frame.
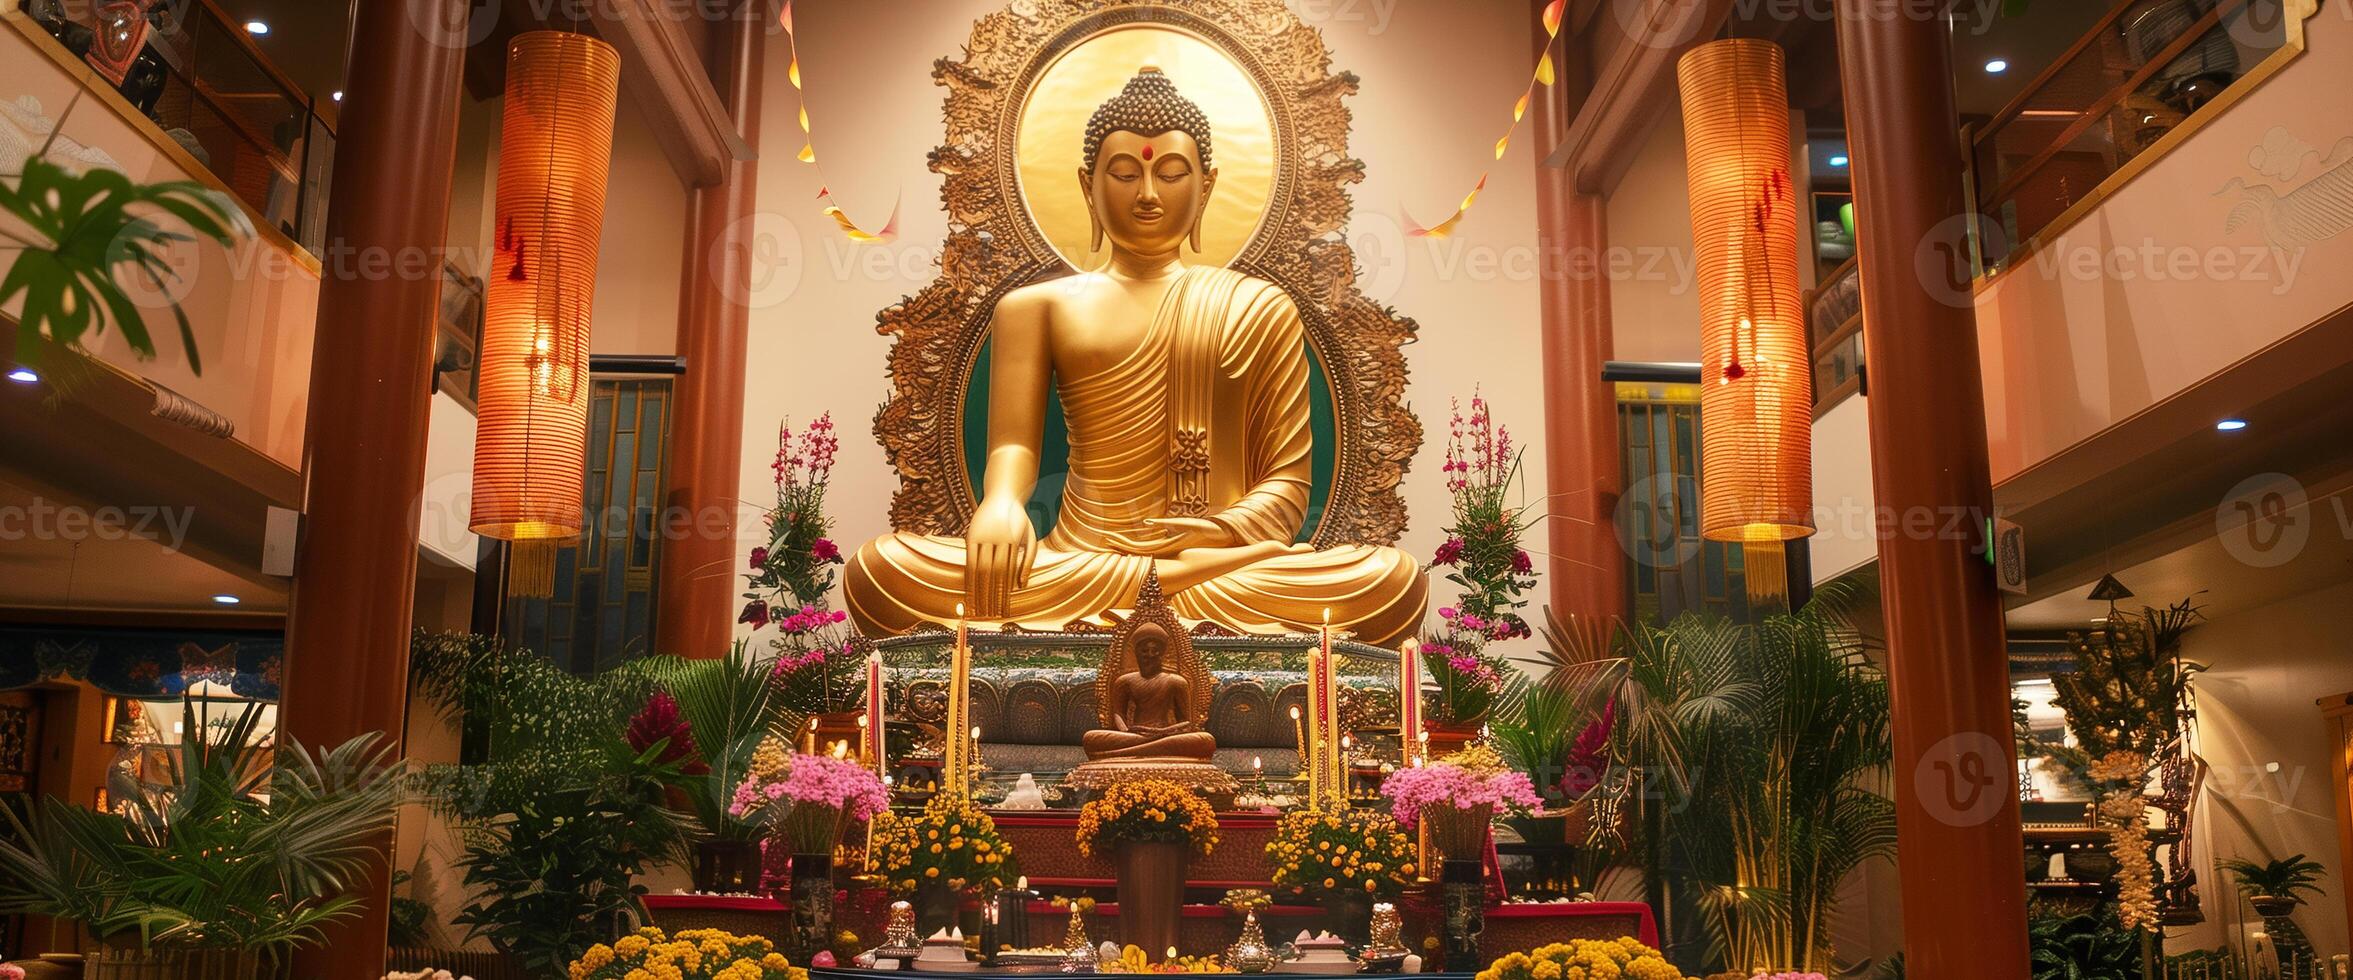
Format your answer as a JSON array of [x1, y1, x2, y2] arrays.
[[741, 0, 1562, 626]]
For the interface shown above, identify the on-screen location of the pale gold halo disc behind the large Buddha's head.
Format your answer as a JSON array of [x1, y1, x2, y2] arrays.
[[1014, 24, 1278, 269]]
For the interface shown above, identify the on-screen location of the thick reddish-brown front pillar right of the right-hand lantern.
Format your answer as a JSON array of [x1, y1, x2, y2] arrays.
[[1838, 0, 2026, 980]]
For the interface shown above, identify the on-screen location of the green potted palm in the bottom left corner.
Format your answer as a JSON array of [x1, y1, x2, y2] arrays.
[[0, 704, 407, 980]]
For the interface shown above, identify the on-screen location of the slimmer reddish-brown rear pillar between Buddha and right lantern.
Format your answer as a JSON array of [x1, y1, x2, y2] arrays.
[[1529, 2, 1626, 622]]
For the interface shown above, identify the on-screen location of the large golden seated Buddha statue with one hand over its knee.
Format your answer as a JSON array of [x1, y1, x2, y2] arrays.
[[842, 68, 1428, 645]]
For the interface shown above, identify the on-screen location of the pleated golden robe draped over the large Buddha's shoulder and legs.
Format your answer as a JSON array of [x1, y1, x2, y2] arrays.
[[842, 266, 1426, 645]]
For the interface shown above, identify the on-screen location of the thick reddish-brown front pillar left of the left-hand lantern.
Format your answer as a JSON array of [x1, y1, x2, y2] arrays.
[[280, 0, 466, 980]]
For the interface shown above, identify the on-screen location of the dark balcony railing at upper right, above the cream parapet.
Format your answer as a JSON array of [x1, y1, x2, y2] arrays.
[[1967, 0, 2301, 273]]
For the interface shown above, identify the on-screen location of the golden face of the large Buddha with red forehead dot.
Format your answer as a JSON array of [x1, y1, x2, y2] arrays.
[[1078, 130, 1217, 254]]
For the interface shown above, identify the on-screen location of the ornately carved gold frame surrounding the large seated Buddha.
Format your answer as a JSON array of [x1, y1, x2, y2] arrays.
[[875, 0, 1421, 547]]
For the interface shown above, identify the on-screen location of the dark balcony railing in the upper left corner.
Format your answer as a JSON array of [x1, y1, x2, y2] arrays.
[[24, 0, 344, 257]]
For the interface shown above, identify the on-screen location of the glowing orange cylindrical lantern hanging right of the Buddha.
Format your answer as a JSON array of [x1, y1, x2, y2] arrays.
[[1675, 38, 1814, 542]]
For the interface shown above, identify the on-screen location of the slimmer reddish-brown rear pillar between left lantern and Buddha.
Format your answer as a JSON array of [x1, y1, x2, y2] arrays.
[[654, 5, 767, 657]]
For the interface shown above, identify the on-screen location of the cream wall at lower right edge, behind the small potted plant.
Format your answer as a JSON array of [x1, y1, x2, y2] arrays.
[[2167, 582, 2353, 954]]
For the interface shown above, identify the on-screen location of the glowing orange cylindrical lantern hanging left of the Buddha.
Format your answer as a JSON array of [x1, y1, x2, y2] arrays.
[[471, 31, 621, 542]]
